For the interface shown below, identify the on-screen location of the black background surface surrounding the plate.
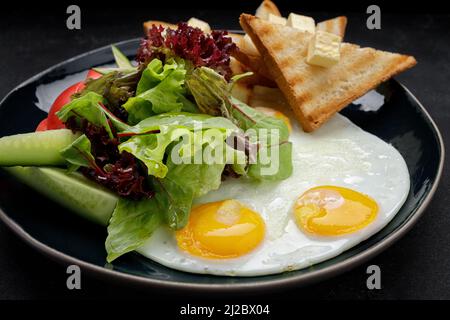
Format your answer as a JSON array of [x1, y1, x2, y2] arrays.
[[0, 1, 450, 303]]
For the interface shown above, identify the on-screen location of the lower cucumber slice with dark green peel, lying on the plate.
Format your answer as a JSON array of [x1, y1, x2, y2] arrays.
[[4, 167, 118, 226]]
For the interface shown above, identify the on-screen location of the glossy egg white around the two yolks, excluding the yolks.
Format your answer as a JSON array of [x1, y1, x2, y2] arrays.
[[137, 115, 410, 276]]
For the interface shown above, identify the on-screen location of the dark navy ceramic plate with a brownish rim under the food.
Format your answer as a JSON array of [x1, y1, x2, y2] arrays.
[[0, 39, 444, 291]]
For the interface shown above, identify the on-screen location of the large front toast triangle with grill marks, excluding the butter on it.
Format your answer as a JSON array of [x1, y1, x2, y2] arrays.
[[240, 14, 416, 132]]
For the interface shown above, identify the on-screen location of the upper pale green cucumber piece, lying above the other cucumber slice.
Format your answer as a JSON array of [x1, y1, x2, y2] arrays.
[[0, 129, 79, 166]]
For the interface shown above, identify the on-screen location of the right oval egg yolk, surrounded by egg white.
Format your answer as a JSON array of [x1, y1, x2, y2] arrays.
[[294, 186, 378, 236]]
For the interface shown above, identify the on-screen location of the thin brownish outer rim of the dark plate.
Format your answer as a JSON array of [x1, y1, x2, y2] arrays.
[[0, 38, 445, 293]]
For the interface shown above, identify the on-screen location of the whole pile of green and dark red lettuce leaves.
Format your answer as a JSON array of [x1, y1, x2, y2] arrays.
[[0, 31, 292, 262]]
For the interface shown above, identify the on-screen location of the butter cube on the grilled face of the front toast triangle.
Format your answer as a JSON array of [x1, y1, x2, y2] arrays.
[[306, 31, 342, 68]]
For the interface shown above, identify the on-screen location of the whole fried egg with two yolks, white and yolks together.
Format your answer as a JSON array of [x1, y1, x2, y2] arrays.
[[137, 115, 410, 276]]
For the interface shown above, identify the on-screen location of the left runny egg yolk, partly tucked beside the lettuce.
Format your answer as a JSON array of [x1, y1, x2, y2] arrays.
[[176, 200, 265, 259]]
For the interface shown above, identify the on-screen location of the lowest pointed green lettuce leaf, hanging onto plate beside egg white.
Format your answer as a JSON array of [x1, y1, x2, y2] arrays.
[[105, 198, 165, 262]]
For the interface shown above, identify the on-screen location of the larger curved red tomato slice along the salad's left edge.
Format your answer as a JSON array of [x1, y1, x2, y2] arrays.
[[47, 69, 102, 130]]
